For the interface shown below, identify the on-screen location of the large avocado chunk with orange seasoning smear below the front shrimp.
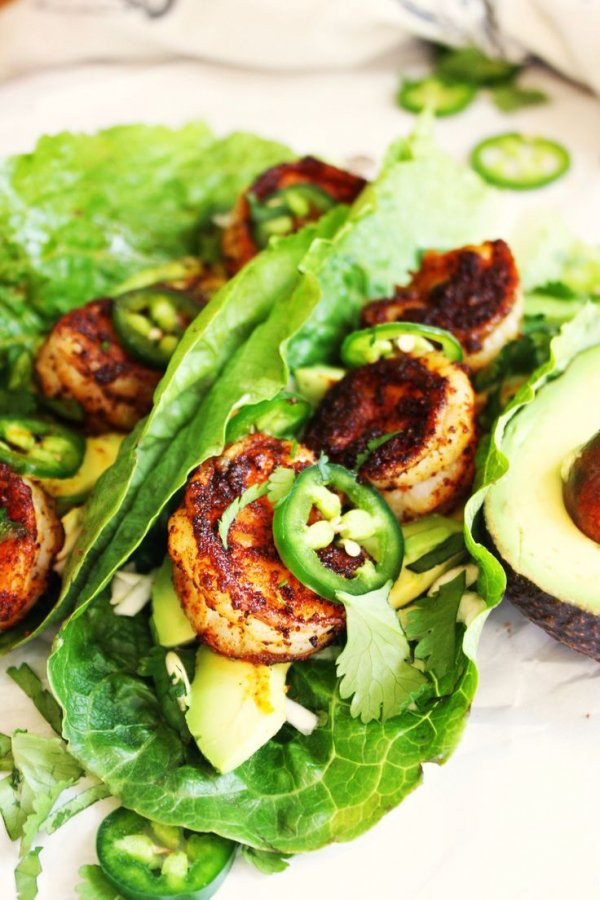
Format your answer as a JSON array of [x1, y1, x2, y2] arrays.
[[186, 646, 289, 772]]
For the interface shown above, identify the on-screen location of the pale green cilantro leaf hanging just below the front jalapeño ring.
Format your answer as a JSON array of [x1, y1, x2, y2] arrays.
[[336, 581, 427, 724]]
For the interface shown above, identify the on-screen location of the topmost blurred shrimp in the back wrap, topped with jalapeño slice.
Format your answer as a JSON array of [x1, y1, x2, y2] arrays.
[[223, 156, 366, 275]]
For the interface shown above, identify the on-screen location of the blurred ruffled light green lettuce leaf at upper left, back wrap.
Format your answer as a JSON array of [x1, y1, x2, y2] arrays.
[[0, 122, 290, 322]]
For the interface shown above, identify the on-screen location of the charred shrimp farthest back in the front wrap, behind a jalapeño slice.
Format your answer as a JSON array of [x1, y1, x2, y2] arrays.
[[362, 241, 523, 371]]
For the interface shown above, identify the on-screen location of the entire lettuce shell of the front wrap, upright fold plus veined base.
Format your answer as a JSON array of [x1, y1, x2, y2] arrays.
[[43, 125, 506, 853]]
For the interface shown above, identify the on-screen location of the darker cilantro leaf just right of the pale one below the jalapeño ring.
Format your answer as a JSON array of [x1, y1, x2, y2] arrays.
[[405, 571, 465, 680]]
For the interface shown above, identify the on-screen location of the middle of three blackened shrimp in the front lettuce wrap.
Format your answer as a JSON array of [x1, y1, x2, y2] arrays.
[[304, 353, 476, 521]]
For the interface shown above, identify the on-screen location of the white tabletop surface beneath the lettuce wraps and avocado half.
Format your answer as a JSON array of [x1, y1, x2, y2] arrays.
[[0, 44, 600, 900]]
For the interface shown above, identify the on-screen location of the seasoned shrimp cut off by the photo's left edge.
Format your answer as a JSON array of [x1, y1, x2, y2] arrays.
[[0, 463, 64, 632]]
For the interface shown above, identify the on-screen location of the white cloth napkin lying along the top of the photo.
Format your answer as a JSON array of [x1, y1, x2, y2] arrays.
[[0, 0, 600, 93]]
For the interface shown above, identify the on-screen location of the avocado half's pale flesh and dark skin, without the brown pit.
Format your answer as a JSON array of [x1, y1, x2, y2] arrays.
[[484, 346, 600, 661]]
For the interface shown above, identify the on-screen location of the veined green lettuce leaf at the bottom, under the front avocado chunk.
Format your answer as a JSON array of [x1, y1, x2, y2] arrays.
[[47, 597, 477, 853]]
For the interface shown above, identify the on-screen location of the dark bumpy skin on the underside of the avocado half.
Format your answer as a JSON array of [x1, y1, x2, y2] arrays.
[[504, 564, 600, 662]]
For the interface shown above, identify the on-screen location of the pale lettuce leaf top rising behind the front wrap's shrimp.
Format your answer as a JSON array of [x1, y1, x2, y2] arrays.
[[288, 122, 496, 369]]
